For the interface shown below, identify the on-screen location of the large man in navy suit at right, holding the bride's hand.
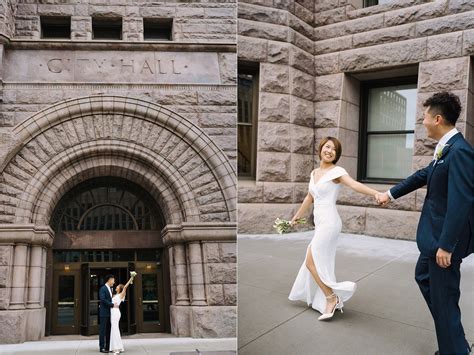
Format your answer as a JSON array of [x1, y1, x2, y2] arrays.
[[376, 92, 474, 355]]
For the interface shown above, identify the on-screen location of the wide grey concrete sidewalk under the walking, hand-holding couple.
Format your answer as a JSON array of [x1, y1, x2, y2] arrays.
[[238, 232, 474, 355]]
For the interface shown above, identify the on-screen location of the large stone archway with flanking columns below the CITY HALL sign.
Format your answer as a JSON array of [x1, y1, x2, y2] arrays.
[[0, 95, 236, 342]]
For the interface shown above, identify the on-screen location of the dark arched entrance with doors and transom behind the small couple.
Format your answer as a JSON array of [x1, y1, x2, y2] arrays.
[[46, 176, 171, 335]]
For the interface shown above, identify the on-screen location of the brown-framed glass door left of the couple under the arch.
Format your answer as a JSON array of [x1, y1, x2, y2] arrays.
[[52, 270, 81, 334]]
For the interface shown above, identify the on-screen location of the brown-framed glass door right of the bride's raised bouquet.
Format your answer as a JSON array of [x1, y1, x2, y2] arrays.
[[135, 265, 165, 333]]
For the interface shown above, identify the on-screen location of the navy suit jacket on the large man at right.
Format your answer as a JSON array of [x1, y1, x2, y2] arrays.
[[390, 133, 474, 259]]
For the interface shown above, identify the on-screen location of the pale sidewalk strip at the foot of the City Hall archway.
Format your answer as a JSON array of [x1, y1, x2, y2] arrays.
[[0, 333, 237, 355]]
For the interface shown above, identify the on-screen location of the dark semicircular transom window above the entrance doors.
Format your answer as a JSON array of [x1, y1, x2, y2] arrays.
[[52, 177, 164, 231]]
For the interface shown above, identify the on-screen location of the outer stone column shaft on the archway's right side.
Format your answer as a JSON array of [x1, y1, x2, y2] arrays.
[[188, 242, 207, 306]]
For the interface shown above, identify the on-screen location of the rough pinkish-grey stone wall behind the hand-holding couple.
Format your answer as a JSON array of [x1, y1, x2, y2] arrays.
[[238, 0, 474, 239]]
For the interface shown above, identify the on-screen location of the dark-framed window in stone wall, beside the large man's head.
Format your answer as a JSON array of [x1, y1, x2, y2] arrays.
[[359, 78, 417, 183]]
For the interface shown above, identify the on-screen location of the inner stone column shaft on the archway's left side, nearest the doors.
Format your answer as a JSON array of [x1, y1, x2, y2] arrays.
[[26, 245, 44, 308]]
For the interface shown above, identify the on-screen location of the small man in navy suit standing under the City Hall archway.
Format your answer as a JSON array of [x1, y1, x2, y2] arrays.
[[99, 275, 115, 353]]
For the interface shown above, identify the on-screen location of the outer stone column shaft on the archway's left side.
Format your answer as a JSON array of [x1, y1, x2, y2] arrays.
[[9, 244, 28, 309]]
